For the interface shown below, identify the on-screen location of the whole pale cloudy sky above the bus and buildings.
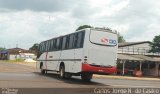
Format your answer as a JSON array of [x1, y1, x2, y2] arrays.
[[0, 0, 160, 49]]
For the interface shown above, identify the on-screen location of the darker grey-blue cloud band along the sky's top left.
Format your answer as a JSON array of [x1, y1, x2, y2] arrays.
[[0, 0, 79, 12]]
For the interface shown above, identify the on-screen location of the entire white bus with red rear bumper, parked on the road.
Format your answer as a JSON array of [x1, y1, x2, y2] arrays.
[[37, 28, 118, 81]]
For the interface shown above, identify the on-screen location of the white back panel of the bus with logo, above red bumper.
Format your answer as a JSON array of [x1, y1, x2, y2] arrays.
[[88, 30, 117, 66]]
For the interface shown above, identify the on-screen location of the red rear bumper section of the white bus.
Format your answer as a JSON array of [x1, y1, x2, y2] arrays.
[[82, 63, 117, 74]]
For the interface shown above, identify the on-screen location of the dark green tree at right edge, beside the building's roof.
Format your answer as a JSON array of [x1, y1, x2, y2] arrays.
[[150, 35, 160, 53]]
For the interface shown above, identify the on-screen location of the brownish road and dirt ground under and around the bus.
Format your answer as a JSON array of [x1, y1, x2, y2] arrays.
[[0, 61, 160, 89]]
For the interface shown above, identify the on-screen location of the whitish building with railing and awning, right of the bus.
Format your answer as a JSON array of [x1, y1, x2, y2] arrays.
[[118, 41, 160, 76]]
